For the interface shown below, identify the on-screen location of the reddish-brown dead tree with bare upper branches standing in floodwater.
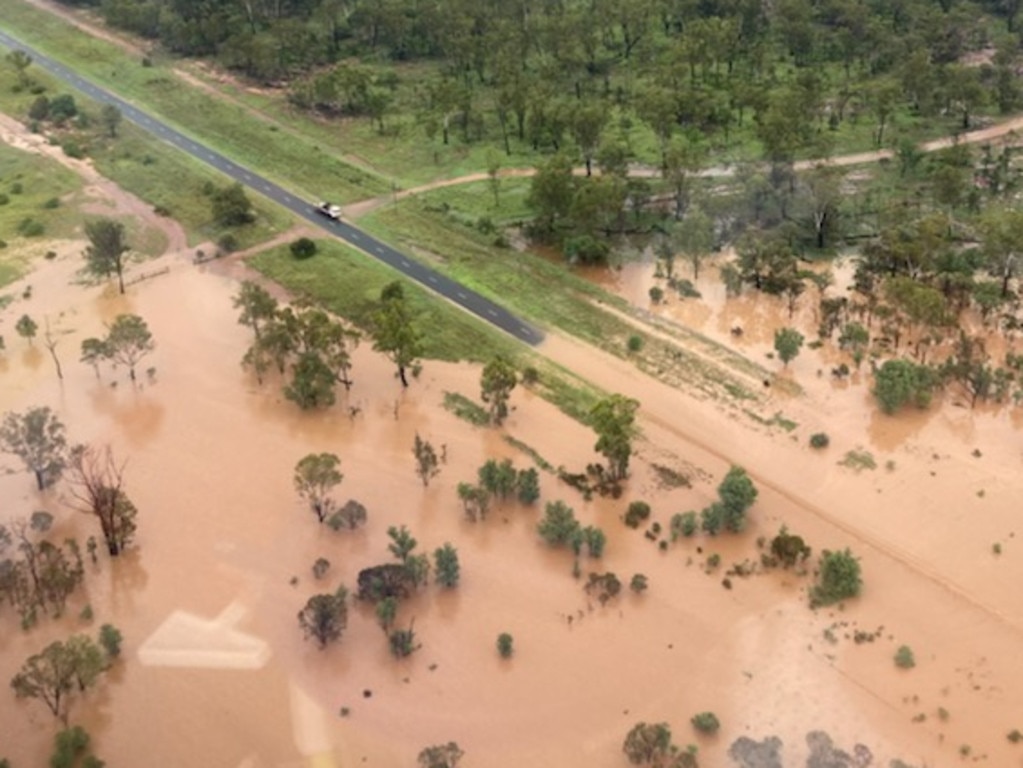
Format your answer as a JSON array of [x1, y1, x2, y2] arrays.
[[70, 445, 138, 557]]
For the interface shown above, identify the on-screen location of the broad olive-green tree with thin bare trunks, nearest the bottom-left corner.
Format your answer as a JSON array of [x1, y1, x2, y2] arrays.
[[10, 635, 105, 725]]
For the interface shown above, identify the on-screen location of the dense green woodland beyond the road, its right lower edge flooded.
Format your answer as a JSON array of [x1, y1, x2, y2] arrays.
[[15, 0, 1023, 409]]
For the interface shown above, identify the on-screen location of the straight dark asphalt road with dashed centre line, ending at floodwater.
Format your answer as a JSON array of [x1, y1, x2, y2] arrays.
[[0, 31, 543, 345]]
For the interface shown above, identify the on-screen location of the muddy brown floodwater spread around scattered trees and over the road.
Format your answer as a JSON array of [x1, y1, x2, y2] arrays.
[[0, 126, 1023, 768]]
